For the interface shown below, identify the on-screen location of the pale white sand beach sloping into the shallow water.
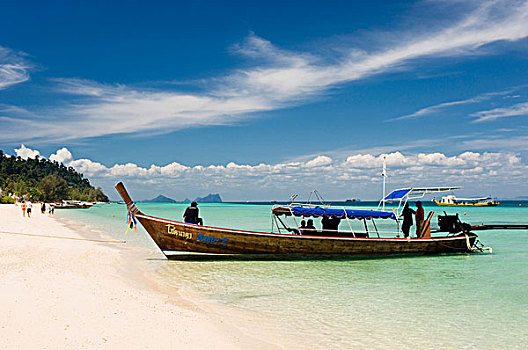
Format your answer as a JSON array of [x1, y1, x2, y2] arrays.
[[0, 205, 277, 349]]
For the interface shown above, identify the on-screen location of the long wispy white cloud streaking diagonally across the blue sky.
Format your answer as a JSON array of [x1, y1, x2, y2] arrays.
[[2, 1, 528, 141]]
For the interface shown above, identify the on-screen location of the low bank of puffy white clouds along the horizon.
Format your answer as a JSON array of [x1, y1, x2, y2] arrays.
[[6, 145, 528, 200]]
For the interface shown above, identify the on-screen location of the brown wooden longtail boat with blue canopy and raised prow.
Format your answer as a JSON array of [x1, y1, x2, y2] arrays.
[[115, 182, 490, 257]]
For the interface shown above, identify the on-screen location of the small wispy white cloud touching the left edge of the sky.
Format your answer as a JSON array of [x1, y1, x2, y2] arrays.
[[0, 46, 30, 90]]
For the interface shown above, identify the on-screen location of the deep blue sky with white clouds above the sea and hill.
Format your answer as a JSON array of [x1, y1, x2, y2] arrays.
[[0, 0, 528, 200]]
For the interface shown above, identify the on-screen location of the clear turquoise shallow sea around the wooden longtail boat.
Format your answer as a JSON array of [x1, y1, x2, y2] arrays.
[[55, 201, 528, 349]]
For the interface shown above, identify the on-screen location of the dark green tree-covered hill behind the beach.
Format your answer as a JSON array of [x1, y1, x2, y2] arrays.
[[0, 150, 108, 203]]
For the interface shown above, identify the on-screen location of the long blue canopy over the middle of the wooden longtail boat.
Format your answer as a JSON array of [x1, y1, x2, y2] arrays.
[[272, 206, 396, 220]]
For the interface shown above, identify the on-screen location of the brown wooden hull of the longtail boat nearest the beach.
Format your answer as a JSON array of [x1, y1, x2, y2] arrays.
[[136, 214, 477, 256]]
